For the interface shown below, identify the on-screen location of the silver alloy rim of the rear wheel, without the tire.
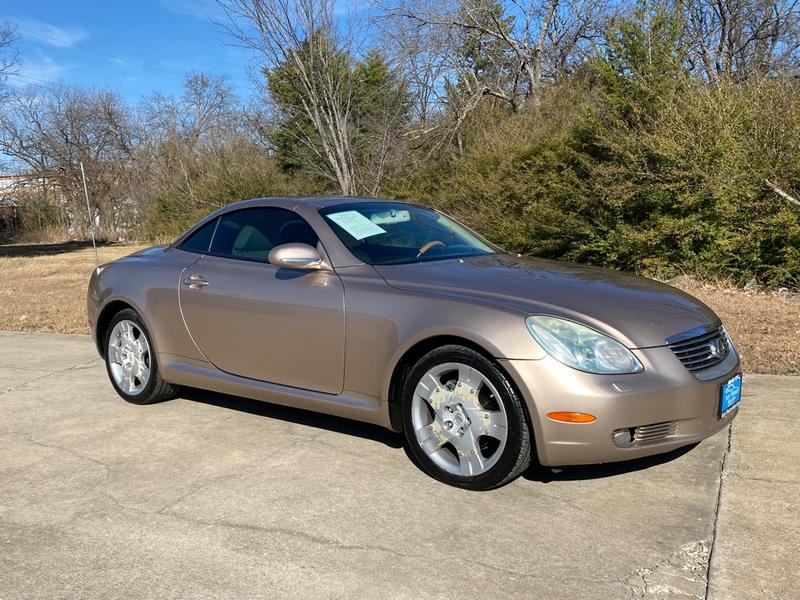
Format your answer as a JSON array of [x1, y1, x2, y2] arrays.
[[108, 320, 151, 396]]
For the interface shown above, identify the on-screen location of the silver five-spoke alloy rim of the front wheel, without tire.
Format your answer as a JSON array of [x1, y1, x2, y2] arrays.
[[411, 363, 508, 477]]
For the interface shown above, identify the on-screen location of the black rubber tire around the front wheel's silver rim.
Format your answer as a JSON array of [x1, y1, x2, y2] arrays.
[[402, 345, 532, 490]]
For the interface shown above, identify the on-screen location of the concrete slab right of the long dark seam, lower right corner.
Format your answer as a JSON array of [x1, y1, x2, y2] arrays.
[[708, 375, 800, 599]]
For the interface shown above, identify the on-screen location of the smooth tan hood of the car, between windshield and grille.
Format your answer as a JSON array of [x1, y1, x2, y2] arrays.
[[375, 254, 720, 348]]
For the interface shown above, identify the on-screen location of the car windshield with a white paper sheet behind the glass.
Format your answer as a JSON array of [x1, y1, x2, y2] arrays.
[[320, 202, 498, 265]]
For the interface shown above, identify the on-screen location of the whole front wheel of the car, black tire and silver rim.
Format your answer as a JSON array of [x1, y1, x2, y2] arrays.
[[403, 345, 531, 490]]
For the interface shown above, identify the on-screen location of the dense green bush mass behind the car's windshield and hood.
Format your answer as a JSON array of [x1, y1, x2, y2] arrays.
[[387, 78, 800, 286]]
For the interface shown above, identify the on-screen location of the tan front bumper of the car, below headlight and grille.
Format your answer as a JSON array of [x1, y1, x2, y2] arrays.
[[500, 346, 739, 466]]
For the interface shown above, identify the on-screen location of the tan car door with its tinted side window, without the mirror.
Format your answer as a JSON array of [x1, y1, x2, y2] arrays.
[[179, 207, 344, 394]]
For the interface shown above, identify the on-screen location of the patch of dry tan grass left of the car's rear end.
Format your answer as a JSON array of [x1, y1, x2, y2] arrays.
[[0, 242, 142, 333]]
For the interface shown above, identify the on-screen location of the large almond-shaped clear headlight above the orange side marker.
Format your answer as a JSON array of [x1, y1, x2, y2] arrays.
[[525, 315, 644, 374]]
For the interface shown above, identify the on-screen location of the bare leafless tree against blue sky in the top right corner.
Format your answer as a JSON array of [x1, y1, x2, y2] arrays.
[[684, 0, 800, 81]]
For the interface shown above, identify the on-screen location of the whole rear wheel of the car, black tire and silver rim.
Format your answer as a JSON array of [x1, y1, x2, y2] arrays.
[[104, 309, 178, 404]]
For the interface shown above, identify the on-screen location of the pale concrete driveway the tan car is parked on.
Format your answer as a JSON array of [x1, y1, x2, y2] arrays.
[[0, 334, 800, 600]]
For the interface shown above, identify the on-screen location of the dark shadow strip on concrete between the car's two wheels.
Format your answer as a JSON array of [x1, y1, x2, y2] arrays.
[[180, 387, 403, 448]]
